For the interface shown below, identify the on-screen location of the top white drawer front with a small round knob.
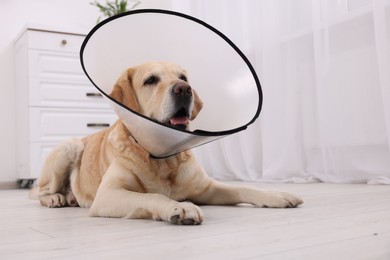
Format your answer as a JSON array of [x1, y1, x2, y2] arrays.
[[27, 30, 85, 53]]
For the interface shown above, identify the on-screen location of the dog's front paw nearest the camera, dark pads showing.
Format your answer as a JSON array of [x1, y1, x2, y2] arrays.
[[169, 202, 203, 225]]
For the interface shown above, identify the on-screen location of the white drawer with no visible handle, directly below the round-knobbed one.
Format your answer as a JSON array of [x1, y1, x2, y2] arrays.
[[28, 50, 86, 80]]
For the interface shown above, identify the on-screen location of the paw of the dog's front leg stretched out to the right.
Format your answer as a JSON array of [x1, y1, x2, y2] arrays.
[[255, 191, 303, 208]]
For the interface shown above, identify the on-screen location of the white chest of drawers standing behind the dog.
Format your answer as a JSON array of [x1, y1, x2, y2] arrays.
[[15, 28, 117, 180]]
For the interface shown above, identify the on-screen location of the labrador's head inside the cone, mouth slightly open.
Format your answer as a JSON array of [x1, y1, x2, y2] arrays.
[[110, 62, 203, 129]]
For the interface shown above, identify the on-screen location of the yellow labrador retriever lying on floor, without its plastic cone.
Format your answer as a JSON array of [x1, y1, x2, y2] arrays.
[[37, 63, 303, 225]]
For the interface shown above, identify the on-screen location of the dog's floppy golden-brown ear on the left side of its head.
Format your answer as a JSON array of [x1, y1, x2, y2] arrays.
[[110, 68, 140, 112]]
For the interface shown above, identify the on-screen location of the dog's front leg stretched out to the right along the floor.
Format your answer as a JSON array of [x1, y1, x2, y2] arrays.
[[191, 180, 303, 208]]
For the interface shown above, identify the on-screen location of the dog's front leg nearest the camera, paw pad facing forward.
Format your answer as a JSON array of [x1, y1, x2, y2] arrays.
[[89, 162, 203, 225]]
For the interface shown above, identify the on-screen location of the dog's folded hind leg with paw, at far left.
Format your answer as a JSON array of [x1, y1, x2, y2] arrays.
[[38, 138, 84, 208]]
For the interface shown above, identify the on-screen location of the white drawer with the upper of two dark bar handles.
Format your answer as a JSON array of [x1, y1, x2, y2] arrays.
[[29, 78, 110, 109]]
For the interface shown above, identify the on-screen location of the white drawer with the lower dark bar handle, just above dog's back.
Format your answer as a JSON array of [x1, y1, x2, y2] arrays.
[[29, 107, 117, 142]]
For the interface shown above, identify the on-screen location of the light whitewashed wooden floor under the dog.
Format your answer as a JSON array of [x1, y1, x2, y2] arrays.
[[0, 183, 390, 260]]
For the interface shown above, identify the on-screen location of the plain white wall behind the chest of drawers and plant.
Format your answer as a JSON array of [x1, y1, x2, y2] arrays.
[[0, 0, 171, 182]]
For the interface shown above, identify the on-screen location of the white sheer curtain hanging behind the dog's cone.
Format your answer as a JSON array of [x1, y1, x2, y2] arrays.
[[172, 0, 390, 184]]
